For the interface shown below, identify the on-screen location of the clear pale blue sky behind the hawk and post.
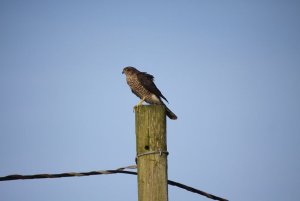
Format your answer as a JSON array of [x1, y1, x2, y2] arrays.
[[0, 0, 300, 201]]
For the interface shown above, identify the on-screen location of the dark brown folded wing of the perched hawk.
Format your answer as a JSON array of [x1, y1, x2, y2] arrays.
[[137, 72, 168, 102]]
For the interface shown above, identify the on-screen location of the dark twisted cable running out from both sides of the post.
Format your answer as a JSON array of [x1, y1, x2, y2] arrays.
[[0, 165, 228, 201]]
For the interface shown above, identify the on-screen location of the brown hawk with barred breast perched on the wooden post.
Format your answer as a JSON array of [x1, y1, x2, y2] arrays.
[[122, 66, 177, 120]]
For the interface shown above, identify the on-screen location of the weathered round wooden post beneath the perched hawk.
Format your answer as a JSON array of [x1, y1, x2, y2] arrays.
[[135, 105, 168, 201]]
